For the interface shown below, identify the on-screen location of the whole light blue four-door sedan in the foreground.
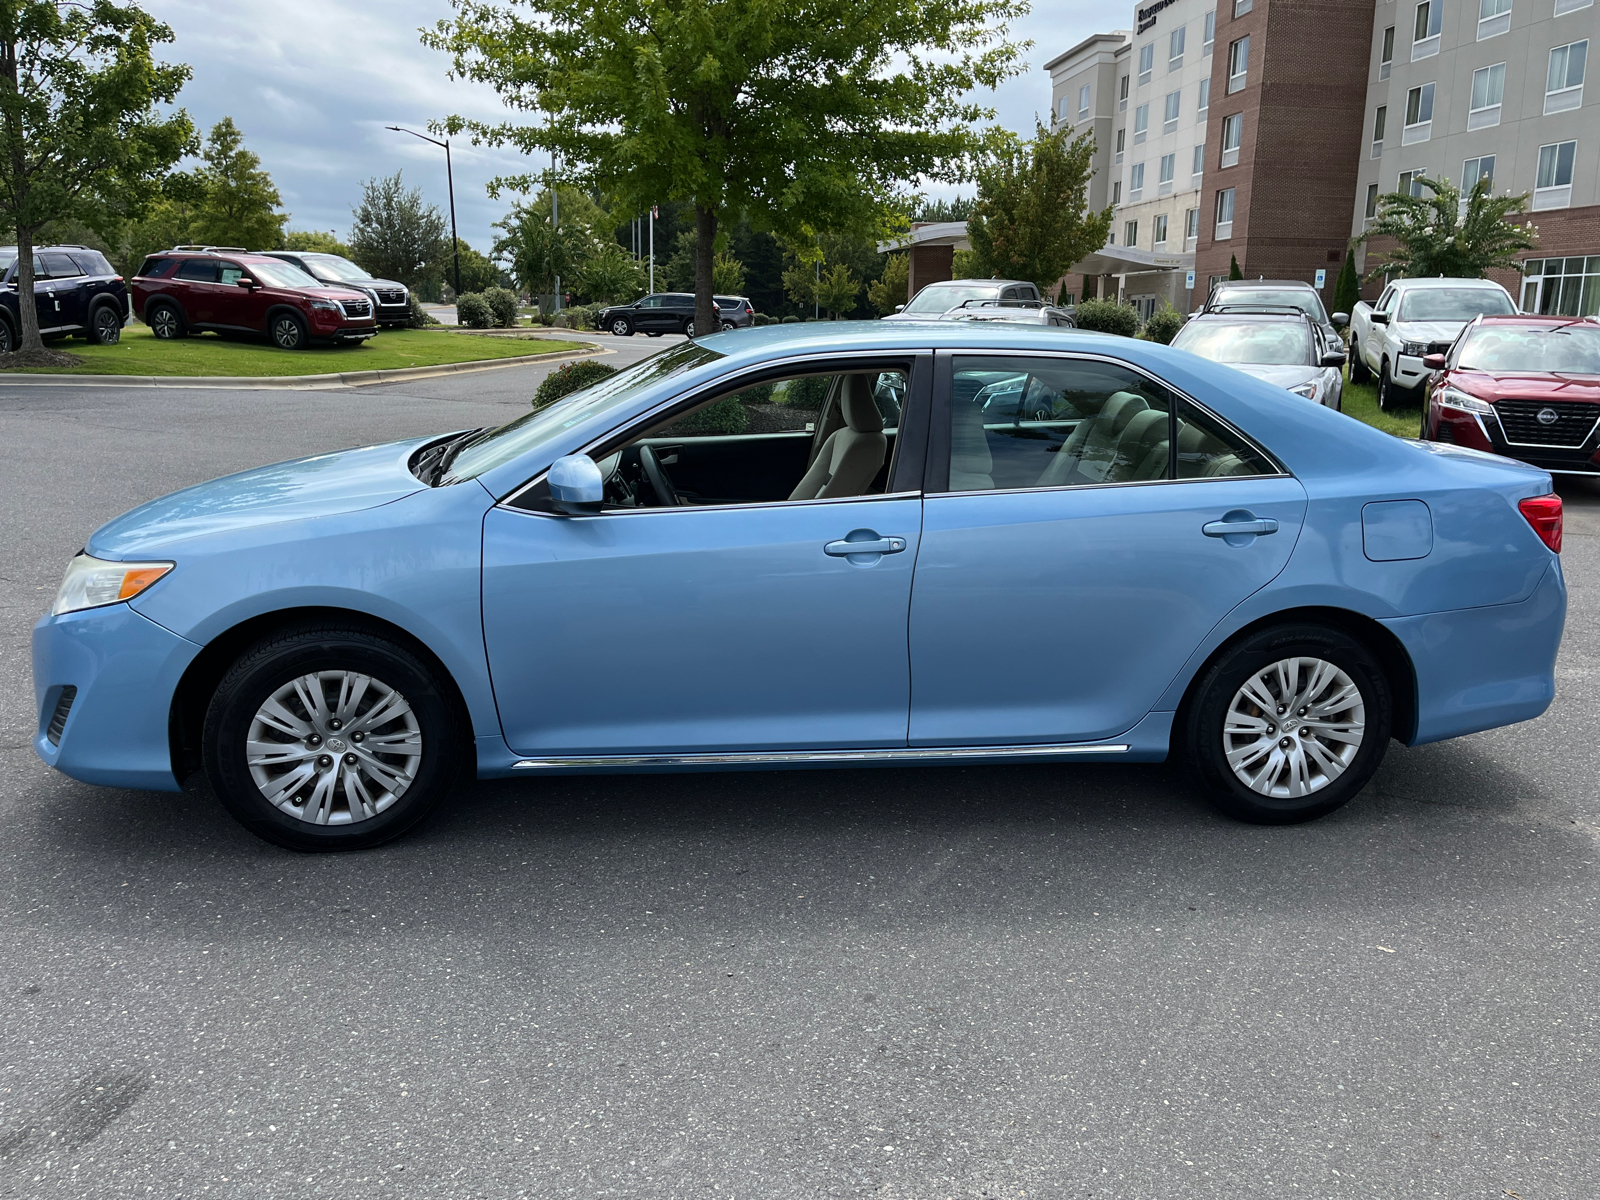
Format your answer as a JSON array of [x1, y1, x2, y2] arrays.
[[34, 322, 1566, 850]]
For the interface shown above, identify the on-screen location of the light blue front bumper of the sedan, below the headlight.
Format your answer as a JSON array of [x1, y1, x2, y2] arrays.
[[34, 605, 200, 792]]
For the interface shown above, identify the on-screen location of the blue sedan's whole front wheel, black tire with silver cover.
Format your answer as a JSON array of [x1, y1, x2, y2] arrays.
[[202, 624, 461, 851]]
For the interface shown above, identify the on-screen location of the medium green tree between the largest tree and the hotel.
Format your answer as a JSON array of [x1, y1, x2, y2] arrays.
[[966, 122, 1112, 293]]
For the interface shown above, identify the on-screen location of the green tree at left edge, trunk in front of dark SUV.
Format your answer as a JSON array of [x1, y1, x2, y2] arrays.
[[0, 0, 195, 352]]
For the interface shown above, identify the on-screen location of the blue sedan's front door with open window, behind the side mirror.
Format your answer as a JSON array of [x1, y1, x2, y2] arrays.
[[483, 352, 922, 755]]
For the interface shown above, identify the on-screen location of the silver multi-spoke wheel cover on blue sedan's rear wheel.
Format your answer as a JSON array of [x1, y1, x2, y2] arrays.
[[1222, 658, 1366, 800]]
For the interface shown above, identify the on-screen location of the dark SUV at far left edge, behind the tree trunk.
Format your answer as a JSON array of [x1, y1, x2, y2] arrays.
[[0, 246, 128, 354]]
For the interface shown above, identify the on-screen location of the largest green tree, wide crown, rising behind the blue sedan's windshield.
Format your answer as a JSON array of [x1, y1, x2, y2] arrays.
[[424, 0, 1027, 342]]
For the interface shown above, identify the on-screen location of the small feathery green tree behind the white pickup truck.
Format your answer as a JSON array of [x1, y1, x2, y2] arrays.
[[1357, 178, 1539, 278]]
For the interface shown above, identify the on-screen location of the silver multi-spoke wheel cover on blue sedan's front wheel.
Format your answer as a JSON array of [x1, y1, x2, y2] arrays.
[[245, 670, 422, 826]]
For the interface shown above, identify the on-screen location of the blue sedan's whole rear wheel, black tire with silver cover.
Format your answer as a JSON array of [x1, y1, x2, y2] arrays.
[[1181, 624, 1394, 826]]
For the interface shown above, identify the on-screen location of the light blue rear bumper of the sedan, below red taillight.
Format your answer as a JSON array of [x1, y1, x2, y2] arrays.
[[1382, 560, 1566, 746]]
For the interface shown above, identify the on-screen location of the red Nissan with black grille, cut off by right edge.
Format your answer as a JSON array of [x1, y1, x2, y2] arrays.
[[1422, 314, 1600, 475]]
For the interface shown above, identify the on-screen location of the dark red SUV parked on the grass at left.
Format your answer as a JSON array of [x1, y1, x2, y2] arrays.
[[131, 246, 378, 350]]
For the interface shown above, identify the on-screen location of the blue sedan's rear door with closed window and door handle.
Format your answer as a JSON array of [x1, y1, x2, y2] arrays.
[[910, 355, 1306, 746]]
